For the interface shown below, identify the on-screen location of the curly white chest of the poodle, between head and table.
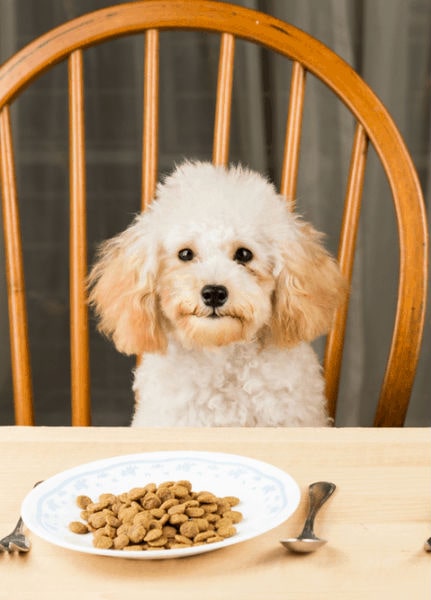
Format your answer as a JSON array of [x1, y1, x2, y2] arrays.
[[134, 344, 323, 427]]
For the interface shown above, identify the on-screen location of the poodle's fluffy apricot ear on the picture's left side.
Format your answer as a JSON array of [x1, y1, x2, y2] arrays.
[[88, 215, 167, 355]]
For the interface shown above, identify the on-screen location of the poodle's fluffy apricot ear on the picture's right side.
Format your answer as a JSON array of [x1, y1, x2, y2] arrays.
[[271, 217, 347, 346]]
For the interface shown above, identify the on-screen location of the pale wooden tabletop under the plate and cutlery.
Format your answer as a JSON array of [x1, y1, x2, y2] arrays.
[[0, 427, 431, 600]]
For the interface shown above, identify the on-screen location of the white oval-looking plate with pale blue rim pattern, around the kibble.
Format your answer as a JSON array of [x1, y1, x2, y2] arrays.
[[21, 451, 300, 559]]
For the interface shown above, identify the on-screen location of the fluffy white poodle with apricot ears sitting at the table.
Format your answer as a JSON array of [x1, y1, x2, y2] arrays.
[[89, 162, 345, 427]]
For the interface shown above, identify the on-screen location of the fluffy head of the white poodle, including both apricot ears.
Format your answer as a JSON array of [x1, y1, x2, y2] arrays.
[[89, 163, 345, 354]]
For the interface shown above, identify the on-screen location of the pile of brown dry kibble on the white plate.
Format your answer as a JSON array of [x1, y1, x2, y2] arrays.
[[69, 481, 242, 550]]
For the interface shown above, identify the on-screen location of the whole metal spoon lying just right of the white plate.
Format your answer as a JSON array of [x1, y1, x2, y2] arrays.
[[280, 481, 336, 553]]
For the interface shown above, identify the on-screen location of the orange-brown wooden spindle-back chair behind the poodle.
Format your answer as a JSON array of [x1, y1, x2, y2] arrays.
[[0, 0, 427, 426]]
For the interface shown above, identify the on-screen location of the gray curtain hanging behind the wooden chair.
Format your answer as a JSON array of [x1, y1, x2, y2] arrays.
[[0, 0, 431, 426]]
